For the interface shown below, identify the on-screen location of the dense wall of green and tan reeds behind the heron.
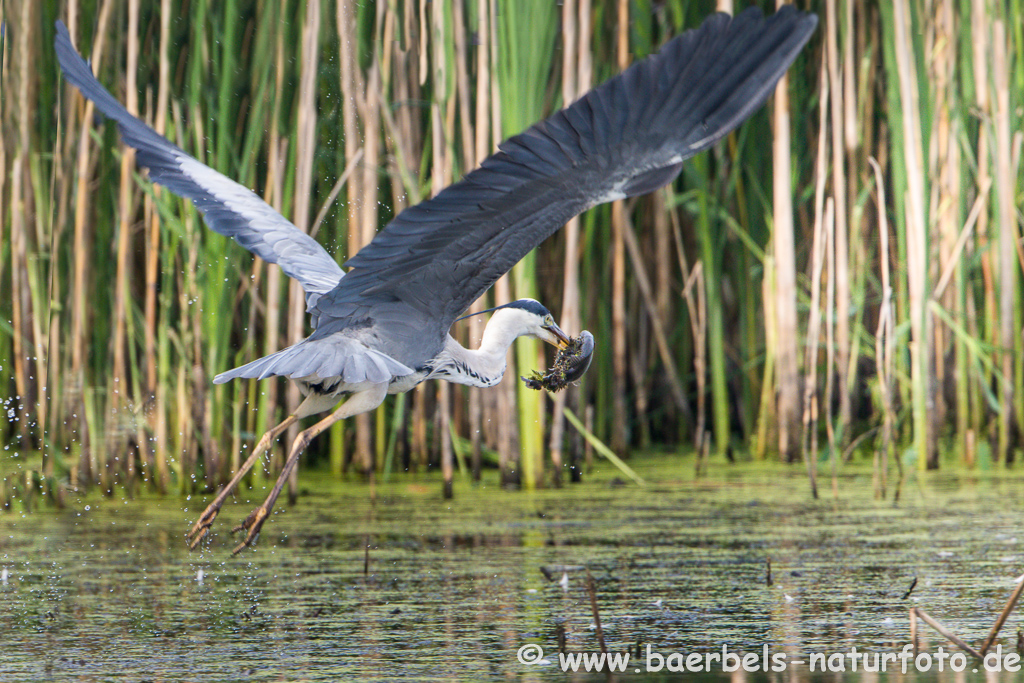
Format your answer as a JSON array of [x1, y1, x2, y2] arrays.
[[0, 0, 1024, 506]]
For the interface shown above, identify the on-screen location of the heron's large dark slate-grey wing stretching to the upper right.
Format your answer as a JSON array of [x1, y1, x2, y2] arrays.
[[316, 5, 817, 362]]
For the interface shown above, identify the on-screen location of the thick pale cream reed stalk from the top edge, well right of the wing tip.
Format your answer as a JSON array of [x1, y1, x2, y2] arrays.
[[893, 0, 938, 470]]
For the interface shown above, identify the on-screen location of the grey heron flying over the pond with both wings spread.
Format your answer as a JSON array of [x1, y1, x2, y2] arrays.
[[55, 6, 817, 553]]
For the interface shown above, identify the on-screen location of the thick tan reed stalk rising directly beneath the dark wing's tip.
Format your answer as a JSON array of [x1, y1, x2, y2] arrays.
[[771, 2, 800, 461]]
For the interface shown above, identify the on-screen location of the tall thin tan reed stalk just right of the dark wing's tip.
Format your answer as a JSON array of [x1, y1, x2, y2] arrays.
[[819, 0, 853, 439]]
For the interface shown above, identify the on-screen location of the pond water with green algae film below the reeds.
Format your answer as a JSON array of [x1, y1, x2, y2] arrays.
[[0, 456, 1024, 681]]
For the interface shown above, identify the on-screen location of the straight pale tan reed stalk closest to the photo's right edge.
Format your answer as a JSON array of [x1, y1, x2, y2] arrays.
[[992, 19, 1018, 464]]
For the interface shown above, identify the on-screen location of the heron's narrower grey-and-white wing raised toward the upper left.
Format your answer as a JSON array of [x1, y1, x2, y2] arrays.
[[54, 20, 344, 308]]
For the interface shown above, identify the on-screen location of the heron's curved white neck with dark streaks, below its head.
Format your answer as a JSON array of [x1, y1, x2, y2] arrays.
[[430, 309, 529, 387]]
